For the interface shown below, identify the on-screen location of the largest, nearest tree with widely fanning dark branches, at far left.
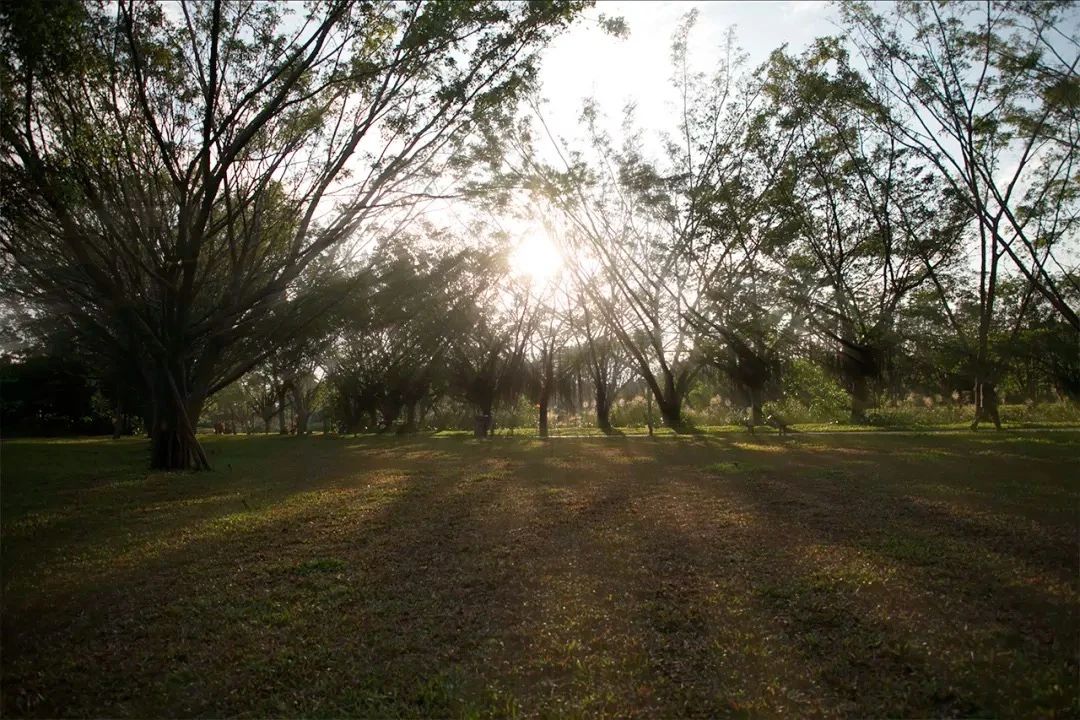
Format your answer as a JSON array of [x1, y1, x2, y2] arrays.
[[0, 0, 582, 468]]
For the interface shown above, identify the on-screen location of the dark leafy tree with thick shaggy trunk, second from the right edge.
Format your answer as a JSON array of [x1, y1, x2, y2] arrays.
[[768, 39, 967, 422]]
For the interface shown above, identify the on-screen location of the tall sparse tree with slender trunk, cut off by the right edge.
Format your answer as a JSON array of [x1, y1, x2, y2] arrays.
[[842, 1, 1080, 426]]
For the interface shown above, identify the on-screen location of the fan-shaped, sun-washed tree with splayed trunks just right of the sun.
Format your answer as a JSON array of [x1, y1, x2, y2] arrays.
[[531, 13, 812, 427]]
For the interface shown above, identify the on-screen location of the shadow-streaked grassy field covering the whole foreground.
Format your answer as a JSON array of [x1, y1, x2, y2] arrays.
[[0, 432, 1080, 718]]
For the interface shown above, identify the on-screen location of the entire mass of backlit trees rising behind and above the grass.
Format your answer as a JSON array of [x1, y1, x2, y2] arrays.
[[0, 0, 1080, 468]]
